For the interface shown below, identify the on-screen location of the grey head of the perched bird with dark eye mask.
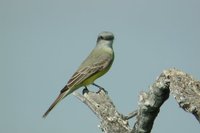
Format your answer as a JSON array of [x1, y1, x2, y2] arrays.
[[97, 31, 114, 42]]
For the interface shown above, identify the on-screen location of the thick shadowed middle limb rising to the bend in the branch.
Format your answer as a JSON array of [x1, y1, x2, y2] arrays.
[[132, 71, 169, 133]]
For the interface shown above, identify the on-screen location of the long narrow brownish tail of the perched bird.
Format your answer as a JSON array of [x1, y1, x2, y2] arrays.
[[42, 86, 71, 118]]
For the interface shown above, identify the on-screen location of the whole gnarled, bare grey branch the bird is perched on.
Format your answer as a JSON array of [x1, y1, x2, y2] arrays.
[[73, 69, 200, 133]]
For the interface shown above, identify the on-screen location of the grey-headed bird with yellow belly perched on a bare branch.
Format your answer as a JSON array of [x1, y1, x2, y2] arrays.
[[43, 31, 114, 118]]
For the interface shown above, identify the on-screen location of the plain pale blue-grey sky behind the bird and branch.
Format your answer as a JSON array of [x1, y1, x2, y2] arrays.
[[0, 0, 200, 133]]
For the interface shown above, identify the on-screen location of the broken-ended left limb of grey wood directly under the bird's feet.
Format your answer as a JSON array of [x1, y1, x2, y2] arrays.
[[73, 89, 131, 133]]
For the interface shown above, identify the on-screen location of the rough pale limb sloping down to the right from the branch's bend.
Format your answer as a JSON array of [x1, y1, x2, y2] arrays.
[[163, 69, 200, 122]]
